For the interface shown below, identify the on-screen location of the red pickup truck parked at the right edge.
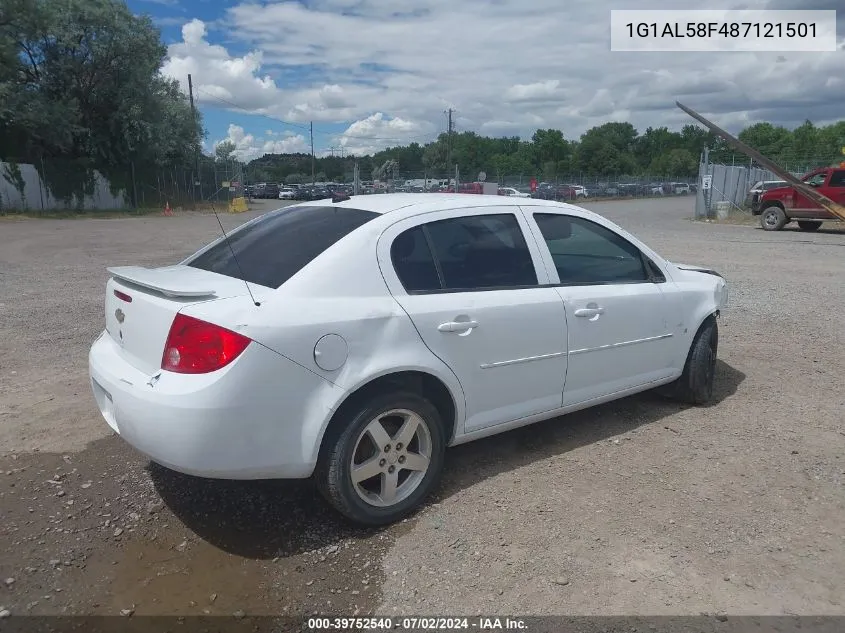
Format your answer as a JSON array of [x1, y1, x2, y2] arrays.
[[754, 163, 845, 231]]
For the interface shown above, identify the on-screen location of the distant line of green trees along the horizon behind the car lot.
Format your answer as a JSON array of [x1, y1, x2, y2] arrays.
[[252, 121, 845, 183]]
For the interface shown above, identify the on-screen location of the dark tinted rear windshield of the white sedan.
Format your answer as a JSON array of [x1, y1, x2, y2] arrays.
[[187, 206, 378, 288]]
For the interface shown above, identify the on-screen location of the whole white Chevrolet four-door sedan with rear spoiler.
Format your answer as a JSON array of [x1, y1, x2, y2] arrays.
[[89, 194, 727, 525]]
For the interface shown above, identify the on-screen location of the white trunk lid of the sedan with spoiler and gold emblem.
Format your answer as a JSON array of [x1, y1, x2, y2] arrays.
[[105, 265, 268, 374]]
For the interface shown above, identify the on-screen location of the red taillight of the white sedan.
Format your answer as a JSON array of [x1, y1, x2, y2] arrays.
[[161, 314, 251, 374]]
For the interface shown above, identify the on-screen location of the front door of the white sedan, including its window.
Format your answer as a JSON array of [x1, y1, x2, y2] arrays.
[[525, 207, 681, 405]]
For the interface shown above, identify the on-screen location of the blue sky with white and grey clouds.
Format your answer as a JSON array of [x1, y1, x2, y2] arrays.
[[128, 0, 845, 159]]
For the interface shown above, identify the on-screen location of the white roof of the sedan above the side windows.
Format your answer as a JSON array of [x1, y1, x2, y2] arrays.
[[290, 193, 589, 219]]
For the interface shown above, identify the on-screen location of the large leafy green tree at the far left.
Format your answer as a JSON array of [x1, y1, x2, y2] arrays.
[[0, 0, 203, 197]]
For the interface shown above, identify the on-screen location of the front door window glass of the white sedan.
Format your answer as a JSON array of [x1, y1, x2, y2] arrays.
[[534, 213, 650, 285]]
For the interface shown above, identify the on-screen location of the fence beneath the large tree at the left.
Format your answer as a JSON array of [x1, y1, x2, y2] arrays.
[[0, 158, 244, 213]]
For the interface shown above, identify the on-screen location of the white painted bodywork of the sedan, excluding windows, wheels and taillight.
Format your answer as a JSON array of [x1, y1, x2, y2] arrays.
[[89, 193, 726, 479]]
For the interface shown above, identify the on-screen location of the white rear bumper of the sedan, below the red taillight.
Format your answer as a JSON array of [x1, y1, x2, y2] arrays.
[[88, 335, 330, 479]]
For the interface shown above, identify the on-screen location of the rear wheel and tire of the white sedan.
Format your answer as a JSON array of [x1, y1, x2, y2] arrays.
[[315, 392, 447, 526]]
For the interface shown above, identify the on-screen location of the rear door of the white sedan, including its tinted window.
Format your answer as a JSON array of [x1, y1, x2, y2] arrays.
[[378, 207, 566, 432]]
